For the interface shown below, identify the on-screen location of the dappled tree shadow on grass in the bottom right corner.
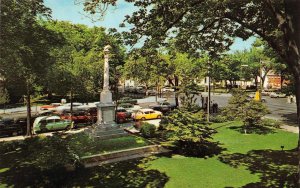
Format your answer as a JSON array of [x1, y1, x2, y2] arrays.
[[219, 150, 298, 188]]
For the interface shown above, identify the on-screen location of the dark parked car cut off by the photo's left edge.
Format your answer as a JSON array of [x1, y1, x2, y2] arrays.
[[0, 118, 26, 136]]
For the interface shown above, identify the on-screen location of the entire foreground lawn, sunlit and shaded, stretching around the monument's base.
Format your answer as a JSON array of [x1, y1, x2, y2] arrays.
[[0, 122, 298, 188]]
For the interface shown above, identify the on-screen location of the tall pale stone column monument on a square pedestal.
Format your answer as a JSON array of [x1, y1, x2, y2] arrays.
[[97, 45, 115, 125]]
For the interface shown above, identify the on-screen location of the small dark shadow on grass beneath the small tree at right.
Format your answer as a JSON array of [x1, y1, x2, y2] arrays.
[[229, 126, 276, 135]]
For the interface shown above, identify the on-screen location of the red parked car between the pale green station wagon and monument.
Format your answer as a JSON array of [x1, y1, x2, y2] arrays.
[[60, 110, 93, 127]]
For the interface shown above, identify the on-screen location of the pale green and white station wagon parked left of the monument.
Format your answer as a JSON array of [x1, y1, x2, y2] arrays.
[[33, 116, 73, 134]]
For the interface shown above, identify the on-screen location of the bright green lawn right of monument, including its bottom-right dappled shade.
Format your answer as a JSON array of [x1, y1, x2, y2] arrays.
[[149, 122, 297, 187]]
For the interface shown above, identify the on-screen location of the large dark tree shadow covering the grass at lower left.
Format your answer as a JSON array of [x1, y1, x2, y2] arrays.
[[0, 137, 168, 187]]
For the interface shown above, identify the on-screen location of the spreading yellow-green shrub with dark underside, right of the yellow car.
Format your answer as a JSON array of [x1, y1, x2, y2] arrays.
[[159, 109, 216, 156]]
